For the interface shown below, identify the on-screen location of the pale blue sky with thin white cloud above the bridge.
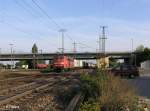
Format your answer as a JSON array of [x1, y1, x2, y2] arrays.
[[0, 0, 150, 53]]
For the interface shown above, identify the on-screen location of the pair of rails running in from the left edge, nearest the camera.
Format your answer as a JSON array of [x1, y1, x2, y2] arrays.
[[0, 78, 65, 108]]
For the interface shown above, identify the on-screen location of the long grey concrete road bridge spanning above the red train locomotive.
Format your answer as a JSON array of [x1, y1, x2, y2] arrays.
[[0, 52, 133, 61]]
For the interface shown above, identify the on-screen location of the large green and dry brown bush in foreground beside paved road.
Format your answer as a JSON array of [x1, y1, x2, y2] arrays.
[[80, 71, 137, 111]]
